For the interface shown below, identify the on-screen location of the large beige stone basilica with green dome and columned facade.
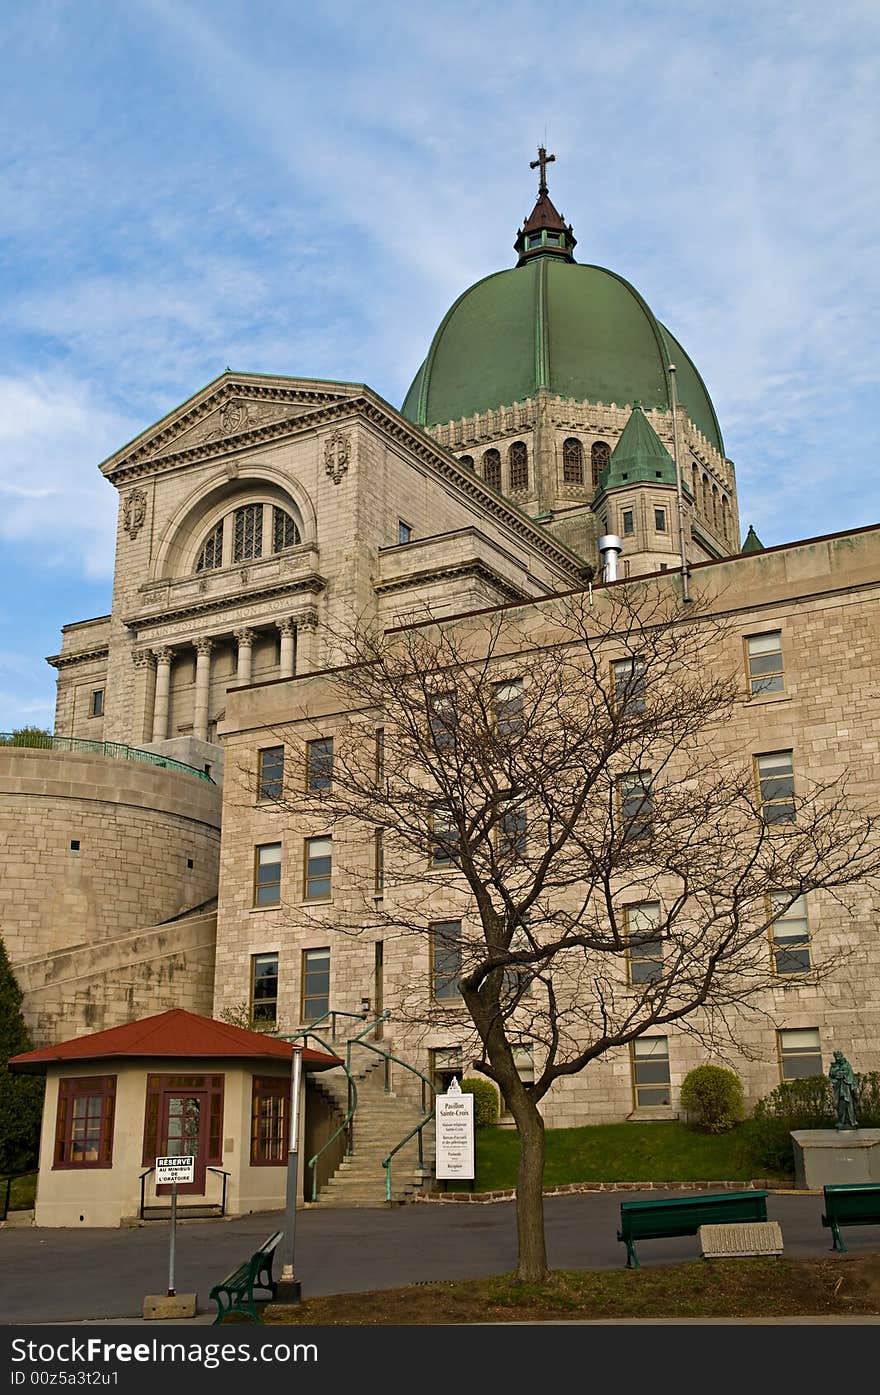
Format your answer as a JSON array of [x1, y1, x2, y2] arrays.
[[6, 151, 880, 1194]]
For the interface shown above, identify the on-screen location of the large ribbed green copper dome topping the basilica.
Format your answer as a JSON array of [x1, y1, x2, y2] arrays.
[[402, 245, 724, 455]]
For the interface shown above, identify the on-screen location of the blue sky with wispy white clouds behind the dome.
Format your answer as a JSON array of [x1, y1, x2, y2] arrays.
[[0, 0, 880, 731]]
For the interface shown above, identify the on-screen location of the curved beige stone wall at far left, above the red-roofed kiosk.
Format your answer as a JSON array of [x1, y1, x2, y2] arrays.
[[0, 746, 220, 970]]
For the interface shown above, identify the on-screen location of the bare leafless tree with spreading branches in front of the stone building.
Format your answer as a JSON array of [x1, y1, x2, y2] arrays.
[[246, 583, 880, 1282]]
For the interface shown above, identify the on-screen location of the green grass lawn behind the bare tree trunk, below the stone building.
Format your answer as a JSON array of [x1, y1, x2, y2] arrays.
[[474, 1122, 787, 1191]]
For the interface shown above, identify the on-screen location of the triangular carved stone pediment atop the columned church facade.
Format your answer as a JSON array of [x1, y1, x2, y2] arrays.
[[100, 372, 364, 478]]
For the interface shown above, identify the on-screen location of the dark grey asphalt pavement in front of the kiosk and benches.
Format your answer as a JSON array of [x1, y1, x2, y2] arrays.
[[0, 1191, 880, 1324]]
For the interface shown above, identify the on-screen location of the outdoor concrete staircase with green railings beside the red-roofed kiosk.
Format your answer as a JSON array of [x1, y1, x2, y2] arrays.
[[315, 1042, 434, 1207]]
